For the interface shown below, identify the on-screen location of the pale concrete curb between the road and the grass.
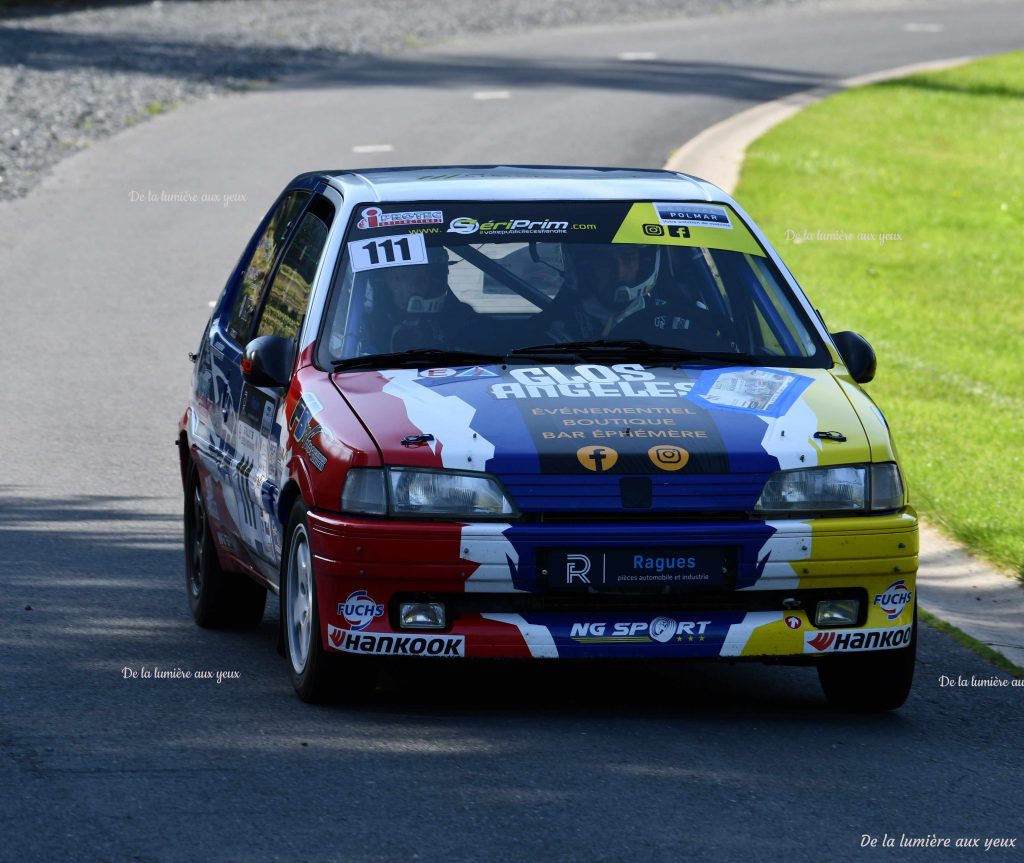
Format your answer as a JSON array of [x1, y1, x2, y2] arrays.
[[665, 57, 1024, 667]]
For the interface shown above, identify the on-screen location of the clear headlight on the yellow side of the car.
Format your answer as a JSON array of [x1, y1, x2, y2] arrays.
[[754, 462, 903, 513]]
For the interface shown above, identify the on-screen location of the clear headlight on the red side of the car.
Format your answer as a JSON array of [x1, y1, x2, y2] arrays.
[[341, 468, 519, 519]]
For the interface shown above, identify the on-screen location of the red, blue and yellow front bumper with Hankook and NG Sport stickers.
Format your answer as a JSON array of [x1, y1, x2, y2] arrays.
[[309, 510, 918, 662]]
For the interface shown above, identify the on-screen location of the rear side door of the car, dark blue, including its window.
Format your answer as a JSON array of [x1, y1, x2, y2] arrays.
[[191, 189, 311, 565]]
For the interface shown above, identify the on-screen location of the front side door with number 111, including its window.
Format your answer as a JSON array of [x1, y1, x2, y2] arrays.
[[232, 195, 335, 580]]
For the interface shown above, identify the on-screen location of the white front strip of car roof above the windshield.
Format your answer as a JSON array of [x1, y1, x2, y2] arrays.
[[323, 165, 732, 204]]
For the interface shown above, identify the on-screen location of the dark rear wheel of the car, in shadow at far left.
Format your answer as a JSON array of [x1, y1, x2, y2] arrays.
[[184, 463, 266, 630]]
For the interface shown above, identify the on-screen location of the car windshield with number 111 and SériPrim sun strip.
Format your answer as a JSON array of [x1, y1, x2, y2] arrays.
[[317, 202, 831, 368]]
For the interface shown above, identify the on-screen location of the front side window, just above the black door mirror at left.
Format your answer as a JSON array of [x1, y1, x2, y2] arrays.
[[256, 197, 334, 339]]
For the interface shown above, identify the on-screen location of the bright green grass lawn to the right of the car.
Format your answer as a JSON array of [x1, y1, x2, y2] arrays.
[[736, 53, 1024, 574]]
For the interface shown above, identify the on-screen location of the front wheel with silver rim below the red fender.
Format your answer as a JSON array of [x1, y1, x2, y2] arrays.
[[281, 501, 375, 704]]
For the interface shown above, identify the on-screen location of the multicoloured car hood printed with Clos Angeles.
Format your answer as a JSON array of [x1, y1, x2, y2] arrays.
[[333, 363, 870, 511]]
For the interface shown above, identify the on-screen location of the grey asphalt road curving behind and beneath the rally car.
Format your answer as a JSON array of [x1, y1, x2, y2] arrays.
[[0, 3, 1024, 861]]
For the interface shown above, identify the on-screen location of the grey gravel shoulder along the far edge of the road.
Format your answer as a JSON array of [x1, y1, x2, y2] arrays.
[[0, 0, 929, 200]]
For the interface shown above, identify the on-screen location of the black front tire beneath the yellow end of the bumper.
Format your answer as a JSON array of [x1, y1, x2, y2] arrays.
[[818, 602, 918, 713]]
